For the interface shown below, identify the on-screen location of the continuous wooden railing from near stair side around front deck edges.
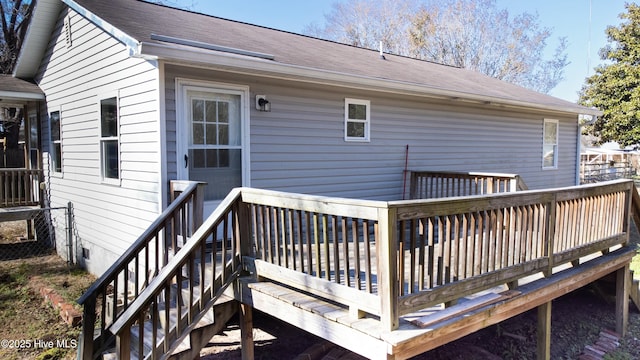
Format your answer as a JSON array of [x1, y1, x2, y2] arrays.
[[110, 181, 633, 358]]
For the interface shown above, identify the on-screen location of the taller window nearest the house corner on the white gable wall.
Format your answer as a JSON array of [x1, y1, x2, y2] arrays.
[[100, 97, 120, 182]]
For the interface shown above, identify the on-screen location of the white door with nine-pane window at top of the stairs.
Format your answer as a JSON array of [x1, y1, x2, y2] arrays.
[[176, 81, 248, 214]]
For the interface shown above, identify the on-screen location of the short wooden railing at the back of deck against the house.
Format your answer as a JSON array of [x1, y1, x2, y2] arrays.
[[409, 171, 527, 199]]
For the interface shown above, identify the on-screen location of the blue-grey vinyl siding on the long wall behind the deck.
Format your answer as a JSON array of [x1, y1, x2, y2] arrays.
[[166, 65, 577, 200]]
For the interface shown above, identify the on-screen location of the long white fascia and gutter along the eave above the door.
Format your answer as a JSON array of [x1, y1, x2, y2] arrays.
[[137, 42, 602, 115]]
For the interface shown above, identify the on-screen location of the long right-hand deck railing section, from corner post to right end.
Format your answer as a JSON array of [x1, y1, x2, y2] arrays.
[[389, 181, 633, 315]]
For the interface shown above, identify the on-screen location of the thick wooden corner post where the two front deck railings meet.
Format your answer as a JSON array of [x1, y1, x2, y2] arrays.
[[376, 208, 400, 331]]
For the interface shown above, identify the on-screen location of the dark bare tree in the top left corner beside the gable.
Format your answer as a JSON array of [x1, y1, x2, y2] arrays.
[[0, 0, 36, 74]]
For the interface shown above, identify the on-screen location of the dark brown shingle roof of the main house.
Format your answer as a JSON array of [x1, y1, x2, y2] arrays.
[[69, 0, 592, 113]]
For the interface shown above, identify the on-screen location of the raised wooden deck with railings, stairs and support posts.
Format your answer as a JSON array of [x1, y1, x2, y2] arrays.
[[81, 176, 635, 359]]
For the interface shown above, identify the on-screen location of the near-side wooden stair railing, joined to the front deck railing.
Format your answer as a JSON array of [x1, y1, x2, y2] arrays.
[[109, 188, 246, 360]]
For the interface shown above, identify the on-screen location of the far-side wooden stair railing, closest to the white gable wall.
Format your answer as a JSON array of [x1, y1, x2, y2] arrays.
[[77, 182, 206, 360]]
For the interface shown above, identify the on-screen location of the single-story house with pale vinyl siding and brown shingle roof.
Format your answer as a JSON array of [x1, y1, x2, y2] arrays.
[[14, 0, 598, 274]]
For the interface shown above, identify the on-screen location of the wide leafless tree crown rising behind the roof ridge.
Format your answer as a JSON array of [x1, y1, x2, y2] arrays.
[[306, 0, 568, 93]]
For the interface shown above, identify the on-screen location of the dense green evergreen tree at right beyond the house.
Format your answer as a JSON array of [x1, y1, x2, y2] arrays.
[[579, 4, 640, 147]]
